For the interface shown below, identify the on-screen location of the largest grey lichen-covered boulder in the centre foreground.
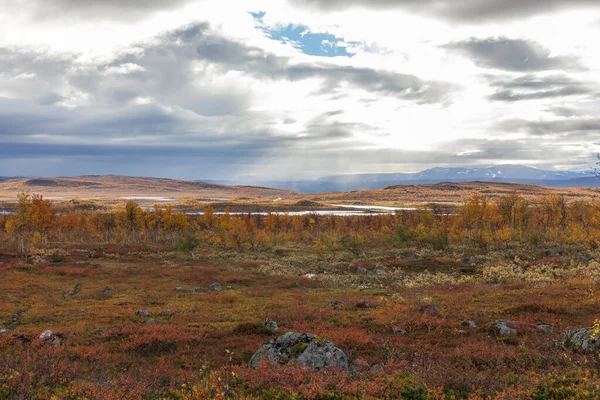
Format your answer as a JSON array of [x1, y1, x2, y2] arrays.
[[249, 332, 349, 370]]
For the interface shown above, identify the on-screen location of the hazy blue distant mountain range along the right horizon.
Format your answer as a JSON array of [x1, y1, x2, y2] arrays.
[[207, 165, 600, 193]]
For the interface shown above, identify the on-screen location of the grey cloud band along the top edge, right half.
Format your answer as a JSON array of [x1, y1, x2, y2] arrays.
[[292, 0, 600, 23]]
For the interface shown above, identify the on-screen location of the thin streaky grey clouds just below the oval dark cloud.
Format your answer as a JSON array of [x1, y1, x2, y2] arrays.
[[488, 74, 600, 102]]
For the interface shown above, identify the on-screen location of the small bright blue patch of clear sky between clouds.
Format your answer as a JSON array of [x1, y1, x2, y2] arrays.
[[250, 12, 360, 57]]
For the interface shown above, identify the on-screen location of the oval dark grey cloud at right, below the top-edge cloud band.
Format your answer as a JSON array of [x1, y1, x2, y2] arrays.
[[443, 38, 582, 71]]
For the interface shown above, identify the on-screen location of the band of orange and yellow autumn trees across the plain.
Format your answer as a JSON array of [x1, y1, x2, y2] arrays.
[[0, 193, 600, 253]]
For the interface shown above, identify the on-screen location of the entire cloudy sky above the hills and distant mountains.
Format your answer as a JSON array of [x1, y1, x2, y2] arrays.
[[0, 0, 600, 181]]
